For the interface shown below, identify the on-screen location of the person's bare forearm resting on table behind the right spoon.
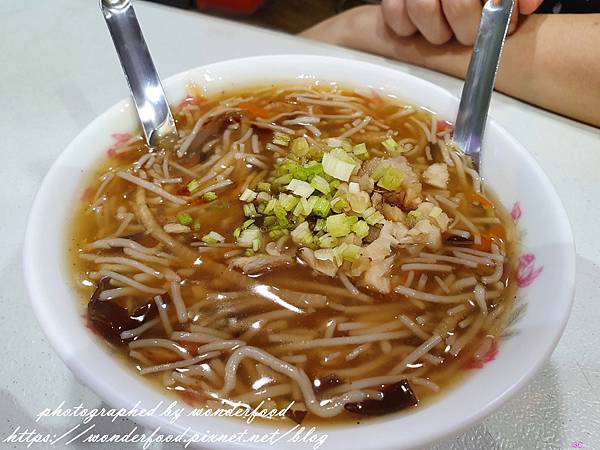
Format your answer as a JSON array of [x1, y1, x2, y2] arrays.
[[302, 6, 600, 126]]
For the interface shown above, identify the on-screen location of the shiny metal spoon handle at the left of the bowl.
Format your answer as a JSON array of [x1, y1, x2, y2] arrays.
[[100, 0, 176, 145]]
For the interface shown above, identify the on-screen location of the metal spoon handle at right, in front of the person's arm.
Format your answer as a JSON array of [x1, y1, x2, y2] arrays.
[[454, 0, 514, 170]]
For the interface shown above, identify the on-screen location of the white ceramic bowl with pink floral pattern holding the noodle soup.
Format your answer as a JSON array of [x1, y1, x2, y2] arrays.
[[24, 55, 575, 450]]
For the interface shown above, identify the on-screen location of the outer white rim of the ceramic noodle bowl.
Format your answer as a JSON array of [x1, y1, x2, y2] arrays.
[[23, 54, 575, 449]]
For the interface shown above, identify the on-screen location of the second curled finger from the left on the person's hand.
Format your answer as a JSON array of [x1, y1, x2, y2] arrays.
[[406, 0, 452, 45]]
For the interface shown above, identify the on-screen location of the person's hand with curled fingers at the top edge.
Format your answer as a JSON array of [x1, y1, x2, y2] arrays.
[[382, 0, 543, 45]]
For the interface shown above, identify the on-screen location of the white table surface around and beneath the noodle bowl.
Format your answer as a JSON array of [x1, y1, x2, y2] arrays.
[[0, 0, 600, 450]]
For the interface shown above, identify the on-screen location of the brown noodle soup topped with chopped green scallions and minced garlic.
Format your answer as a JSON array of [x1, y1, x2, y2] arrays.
[[71, 86, 516, 422]]
